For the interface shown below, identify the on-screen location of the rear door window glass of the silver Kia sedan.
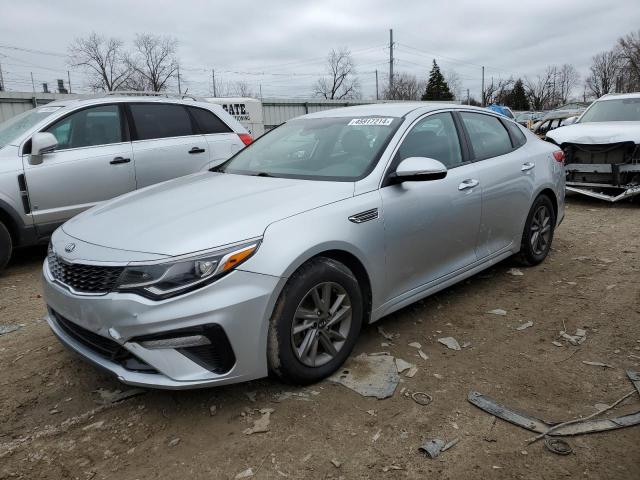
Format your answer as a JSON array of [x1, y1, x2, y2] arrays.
[[460, 112, 513, 160]]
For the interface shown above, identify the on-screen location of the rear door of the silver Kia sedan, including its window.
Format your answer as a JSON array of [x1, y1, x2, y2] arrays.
[[458, 112, 536, 259]]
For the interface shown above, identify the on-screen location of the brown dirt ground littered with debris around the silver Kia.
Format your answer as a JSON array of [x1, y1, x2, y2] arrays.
[[0, 197, 640, 480]]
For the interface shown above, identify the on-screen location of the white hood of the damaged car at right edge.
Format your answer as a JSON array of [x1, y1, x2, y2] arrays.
[[547, 122, 640, 145]]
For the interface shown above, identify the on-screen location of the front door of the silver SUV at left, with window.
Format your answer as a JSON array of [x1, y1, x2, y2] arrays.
[[23, 104, 135, 235]]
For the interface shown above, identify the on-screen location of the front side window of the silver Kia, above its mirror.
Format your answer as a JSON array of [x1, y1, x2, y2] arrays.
[[398, 113, 462, 168]]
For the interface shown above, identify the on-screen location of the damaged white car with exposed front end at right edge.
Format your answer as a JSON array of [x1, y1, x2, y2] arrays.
[[546, 93, 640, 202]]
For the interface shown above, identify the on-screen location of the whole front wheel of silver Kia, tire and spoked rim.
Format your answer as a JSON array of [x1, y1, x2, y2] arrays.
[[267, 257, 363, 385]]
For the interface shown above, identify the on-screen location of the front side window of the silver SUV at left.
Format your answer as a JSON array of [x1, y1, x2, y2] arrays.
[[45, 105, 124, 150]]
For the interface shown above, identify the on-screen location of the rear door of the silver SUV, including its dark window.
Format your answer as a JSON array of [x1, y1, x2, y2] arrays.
[[129, 102, 210, 188]]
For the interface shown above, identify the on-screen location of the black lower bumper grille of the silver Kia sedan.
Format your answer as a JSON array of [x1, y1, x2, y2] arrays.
[[49, 309, 157, 373]]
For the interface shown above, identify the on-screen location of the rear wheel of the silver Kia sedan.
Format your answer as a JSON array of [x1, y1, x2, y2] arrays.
[[519, 195, 556, 266]]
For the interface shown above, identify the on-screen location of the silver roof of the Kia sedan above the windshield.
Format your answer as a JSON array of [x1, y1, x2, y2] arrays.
[[298, 102, 493, 118]]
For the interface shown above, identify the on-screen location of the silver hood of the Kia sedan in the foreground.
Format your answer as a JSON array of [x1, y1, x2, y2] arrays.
[[62, 172, 353, 256]]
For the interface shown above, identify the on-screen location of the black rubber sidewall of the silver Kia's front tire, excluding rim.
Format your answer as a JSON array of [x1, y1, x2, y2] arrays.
[[268, 257, 364, 384]]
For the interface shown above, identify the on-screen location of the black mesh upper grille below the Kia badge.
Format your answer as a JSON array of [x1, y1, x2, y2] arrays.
[[47, 246, 124, 294]]
